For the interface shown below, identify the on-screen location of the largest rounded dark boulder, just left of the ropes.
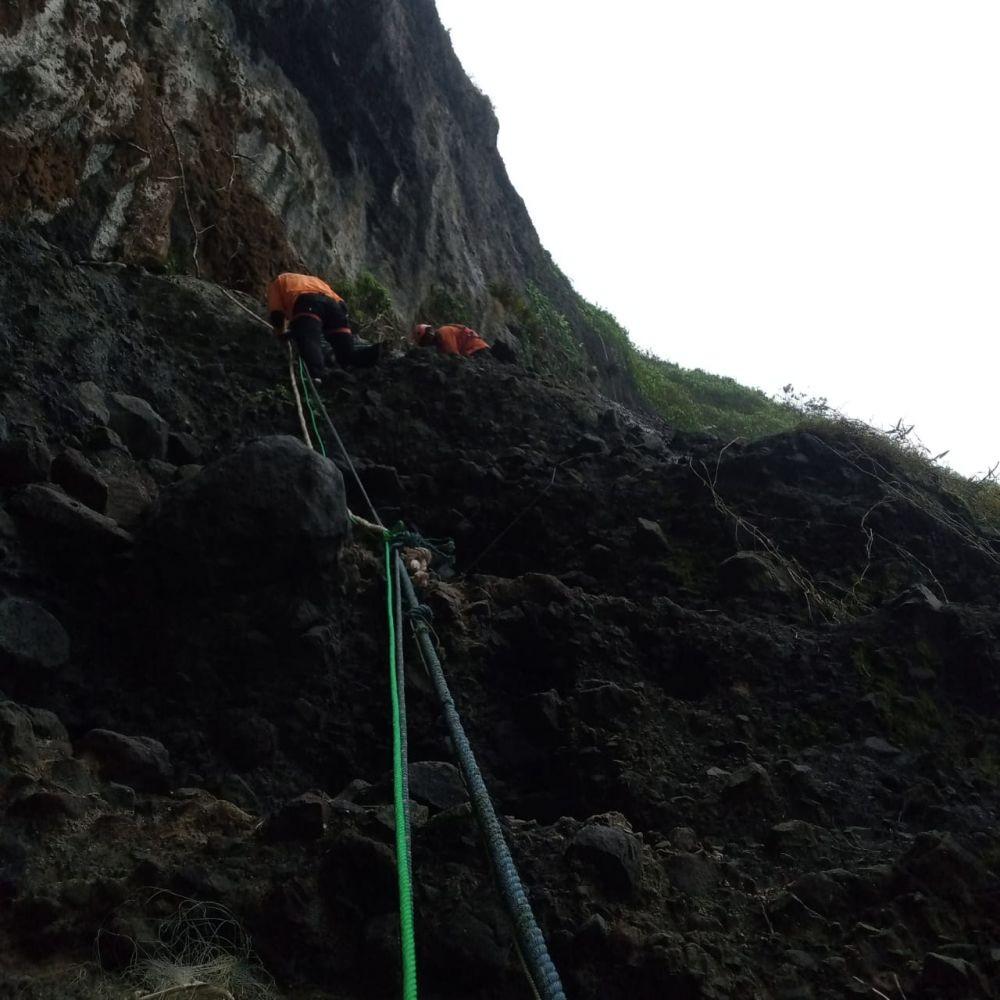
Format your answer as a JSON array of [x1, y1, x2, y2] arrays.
[[139, 437, 350, 593]]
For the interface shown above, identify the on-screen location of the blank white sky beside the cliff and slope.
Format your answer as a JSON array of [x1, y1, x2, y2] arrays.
[[437, 0, 1000, 474]]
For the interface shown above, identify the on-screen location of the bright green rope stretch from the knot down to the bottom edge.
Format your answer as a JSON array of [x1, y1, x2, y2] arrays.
[[385, 532, 417, 1000]]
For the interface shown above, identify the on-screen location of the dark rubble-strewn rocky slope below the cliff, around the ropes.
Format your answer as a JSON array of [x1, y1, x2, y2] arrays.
[[0, 232, 1000, 1000]]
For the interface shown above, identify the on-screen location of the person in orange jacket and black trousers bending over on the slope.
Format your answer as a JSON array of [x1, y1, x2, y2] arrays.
[[267, 273, 379, 380]]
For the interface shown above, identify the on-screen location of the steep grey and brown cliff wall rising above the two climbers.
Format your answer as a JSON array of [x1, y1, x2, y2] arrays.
[[0, 0, 627, 391]]
